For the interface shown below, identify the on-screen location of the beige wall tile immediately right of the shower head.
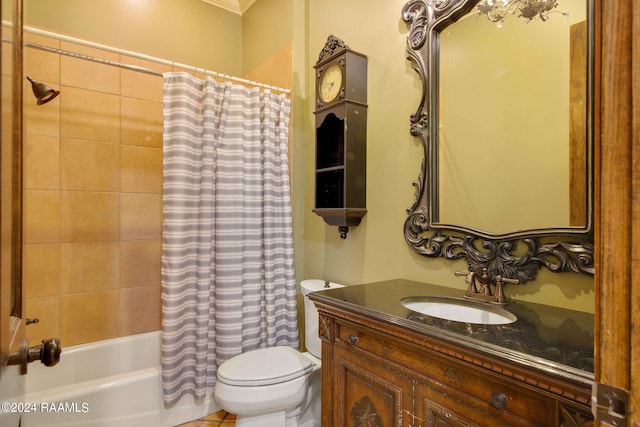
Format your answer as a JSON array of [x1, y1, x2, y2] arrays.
[[61, 86, 120, 143]]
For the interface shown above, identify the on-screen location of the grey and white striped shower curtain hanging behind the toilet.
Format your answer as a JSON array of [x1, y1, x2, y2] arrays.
[[162, 73, 298, 406]]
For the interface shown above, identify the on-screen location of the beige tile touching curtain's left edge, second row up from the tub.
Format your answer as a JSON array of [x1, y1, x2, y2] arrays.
[[120, 240, 162, 288]]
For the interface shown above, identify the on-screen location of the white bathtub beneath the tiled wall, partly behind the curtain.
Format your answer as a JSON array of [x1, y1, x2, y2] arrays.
[[22, 331, 220, 427]]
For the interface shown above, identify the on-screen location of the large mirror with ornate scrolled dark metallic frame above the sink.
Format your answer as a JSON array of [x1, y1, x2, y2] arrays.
[[402, 0, 594, 283]]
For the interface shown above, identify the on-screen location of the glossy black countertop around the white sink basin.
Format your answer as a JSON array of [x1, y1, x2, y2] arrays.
[[310, 279, 594, 380]]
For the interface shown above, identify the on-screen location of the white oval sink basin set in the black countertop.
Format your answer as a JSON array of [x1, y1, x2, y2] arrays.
[[400, 296, 518, 325]]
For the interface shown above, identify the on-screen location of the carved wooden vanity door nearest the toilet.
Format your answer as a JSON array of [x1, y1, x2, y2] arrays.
[[333, 345, 413, 427]]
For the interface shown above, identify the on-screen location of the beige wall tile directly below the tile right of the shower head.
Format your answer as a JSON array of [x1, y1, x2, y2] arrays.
[[60, 139, 120, 191]]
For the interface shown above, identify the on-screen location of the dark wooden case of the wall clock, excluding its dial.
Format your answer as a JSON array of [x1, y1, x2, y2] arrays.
[[313, 36, 367, 239]]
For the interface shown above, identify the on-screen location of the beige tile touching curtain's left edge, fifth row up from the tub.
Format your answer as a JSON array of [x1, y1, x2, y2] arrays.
[[120, 97, 162, 148]]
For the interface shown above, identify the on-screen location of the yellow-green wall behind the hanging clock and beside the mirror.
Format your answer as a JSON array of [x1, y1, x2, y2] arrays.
[[302, 0, 594, 311]]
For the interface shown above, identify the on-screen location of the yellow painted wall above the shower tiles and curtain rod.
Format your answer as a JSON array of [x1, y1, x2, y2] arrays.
[[24, 0, 242, 76]]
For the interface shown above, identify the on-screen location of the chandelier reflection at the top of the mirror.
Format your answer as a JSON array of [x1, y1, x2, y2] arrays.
[[476, 0, 569, 27]]
